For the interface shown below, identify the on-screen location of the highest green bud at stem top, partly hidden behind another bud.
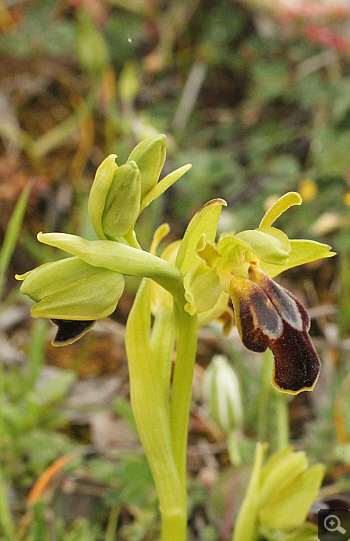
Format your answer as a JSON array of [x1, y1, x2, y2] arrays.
[[128, 134, 166, 201]]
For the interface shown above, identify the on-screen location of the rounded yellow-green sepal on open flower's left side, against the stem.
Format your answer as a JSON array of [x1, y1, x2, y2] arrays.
[[184, 263, 222, 315]]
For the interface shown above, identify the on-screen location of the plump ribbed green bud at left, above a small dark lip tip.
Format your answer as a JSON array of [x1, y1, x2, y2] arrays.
[[16, 257, 124, 321]]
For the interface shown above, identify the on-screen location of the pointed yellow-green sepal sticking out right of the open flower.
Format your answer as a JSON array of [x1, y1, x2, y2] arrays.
[[260, 239, 335, 278]]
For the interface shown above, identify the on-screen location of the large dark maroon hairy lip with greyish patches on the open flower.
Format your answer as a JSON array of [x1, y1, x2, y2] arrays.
[[230, 265, 321, 394]]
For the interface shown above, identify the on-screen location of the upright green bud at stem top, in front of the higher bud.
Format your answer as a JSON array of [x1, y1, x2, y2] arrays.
[[88, 154, 141, 240]]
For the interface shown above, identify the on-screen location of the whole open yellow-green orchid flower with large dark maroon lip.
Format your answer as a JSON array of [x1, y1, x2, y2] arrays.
[[184, 192, 333, 394]]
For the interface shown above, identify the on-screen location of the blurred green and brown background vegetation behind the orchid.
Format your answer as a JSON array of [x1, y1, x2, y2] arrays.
[[0, 0, 350, 541]]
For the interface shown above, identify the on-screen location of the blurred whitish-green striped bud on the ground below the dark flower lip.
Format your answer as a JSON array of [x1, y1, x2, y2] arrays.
[[203, 355, 243, 465]]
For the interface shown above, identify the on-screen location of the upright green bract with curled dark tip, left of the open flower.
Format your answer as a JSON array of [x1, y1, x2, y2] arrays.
[[176, 199, 226, 274]]
